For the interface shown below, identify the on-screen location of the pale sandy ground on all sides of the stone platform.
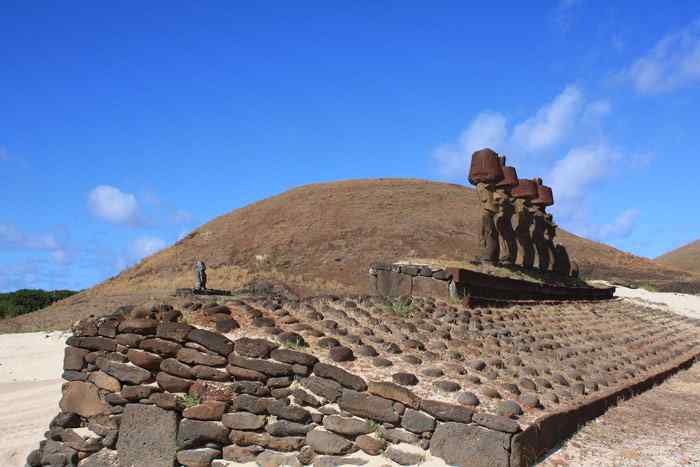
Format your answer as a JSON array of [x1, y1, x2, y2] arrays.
[[0, 287, 700, 467]]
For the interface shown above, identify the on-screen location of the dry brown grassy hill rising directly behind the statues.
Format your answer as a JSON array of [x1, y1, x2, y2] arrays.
[[0, 179, 700, 332]]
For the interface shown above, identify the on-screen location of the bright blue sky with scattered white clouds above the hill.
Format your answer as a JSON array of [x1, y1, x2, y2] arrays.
[[0, 0, 700, 290]]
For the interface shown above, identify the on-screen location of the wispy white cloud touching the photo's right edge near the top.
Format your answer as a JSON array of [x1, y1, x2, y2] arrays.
[[618, 19, 700, 94]]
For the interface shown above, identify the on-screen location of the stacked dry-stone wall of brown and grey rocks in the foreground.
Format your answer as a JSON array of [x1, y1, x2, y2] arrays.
[[27, 307, 521, 467]]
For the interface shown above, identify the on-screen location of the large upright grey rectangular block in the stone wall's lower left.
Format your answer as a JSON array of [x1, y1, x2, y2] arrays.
[[117, 404, 178, 467]]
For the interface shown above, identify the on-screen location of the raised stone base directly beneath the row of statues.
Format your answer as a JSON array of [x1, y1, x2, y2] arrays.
[[369, 261, 615, 304]]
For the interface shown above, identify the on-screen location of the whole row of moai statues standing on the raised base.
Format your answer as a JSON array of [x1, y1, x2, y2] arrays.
[[469, 148, 578, 277]]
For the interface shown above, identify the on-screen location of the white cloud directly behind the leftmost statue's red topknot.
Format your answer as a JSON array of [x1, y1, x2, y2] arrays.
[[433, 111, 508, 177]]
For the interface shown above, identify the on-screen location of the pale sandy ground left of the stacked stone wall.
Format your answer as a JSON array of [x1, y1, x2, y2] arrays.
[[0, 332, 68, 467]]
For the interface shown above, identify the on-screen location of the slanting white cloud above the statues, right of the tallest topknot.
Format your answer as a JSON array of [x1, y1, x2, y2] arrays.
[[513, 85, 584, 151]]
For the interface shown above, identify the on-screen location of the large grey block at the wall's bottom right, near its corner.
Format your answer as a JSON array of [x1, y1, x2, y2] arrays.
[[430, 422, 510, 467]]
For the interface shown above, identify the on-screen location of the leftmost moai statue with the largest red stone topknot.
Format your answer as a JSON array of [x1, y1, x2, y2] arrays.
[[469, 149, 503, 263]]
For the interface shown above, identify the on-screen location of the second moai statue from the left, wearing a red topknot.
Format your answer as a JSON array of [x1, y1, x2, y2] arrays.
[[494, 156, 518, 266]]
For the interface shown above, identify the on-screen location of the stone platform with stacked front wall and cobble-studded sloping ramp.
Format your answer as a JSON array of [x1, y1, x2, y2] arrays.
[[28, 296, 700, 467]]
